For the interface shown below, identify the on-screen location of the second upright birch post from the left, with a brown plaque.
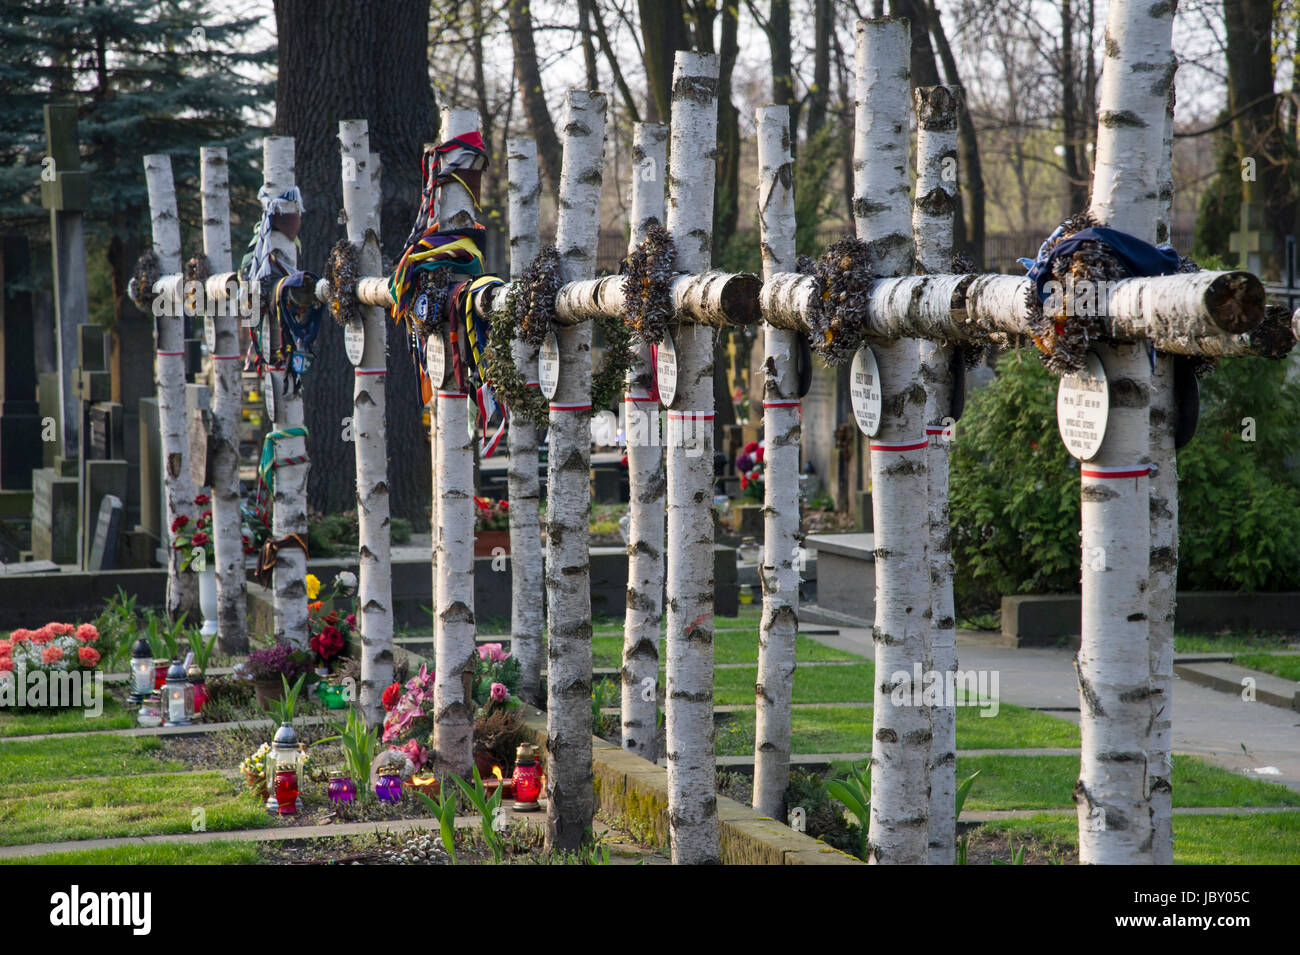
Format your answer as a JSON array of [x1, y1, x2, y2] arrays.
[[199, 146, 248, 654]]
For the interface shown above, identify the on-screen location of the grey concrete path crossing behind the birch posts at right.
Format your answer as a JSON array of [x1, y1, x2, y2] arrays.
[[801, 628, 1300, 791]]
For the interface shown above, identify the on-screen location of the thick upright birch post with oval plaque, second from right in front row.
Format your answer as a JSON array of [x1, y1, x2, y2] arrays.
[[853, 18, 931, 864]]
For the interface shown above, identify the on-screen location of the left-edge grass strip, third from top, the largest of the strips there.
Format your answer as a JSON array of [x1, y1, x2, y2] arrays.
[[0, 772, 269, 846]]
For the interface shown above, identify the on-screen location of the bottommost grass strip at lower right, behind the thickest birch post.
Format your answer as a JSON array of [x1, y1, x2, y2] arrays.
[[983, 810, 1300, 865]]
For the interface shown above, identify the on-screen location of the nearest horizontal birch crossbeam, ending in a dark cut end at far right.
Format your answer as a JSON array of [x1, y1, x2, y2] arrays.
[[761, 272, 1264, 356]]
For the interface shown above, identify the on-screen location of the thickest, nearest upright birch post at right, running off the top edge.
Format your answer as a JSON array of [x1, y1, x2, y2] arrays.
[[1074, 0, 1173, 864]]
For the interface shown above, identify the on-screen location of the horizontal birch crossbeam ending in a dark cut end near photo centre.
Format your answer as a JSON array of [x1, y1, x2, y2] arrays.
[[555, 270, 763, 329]]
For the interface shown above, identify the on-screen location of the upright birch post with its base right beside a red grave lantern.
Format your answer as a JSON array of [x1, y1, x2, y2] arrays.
[[546, 90, 605, 850]]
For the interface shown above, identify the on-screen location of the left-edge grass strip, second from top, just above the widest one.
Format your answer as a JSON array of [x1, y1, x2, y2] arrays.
[[0, 734, 186, 789]]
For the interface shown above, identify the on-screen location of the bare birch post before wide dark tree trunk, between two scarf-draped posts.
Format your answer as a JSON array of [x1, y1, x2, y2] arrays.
[[338, 120, 393, 726]]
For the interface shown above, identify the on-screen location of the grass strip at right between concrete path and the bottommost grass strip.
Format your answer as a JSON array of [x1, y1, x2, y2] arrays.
[[957, 753, 1300, 809]]
